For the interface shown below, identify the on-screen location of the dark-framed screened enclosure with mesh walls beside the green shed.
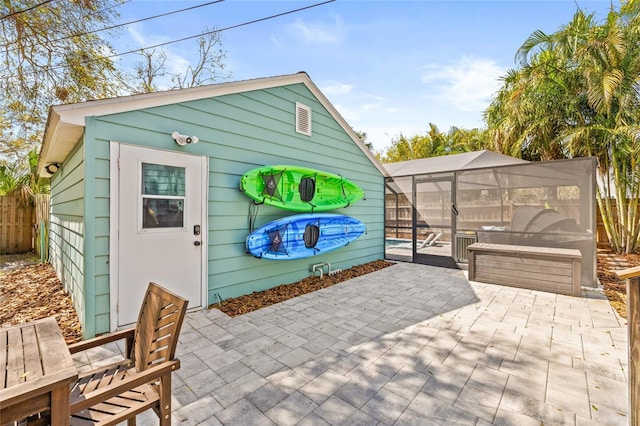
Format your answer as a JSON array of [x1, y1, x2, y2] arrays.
[[385, 151, 596, 287]]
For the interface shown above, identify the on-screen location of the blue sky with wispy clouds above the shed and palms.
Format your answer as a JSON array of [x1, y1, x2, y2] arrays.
[[114, 0, 619, 150]]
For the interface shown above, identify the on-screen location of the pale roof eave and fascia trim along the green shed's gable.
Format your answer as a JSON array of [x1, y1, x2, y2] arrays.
[[38, 72, 387, 177]]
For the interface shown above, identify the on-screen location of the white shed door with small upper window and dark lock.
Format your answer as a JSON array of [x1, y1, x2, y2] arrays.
[[116, 144, 206, 327]]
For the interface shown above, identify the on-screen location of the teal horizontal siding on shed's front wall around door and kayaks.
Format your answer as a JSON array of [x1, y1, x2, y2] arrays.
[[78, 80, 384, 333]]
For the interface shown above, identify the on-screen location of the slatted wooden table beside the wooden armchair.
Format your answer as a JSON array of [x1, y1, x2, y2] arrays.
[[0, 317, 78, 425]]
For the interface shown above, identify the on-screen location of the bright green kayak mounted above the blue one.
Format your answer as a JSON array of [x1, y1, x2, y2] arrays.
[[240, 166, 364, 212]]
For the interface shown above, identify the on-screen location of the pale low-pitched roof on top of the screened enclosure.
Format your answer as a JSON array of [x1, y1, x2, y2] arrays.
[[383, 150, 528, 177]]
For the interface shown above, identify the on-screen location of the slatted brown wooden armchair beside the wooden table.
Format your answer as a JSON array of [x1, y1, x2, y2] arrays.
[[41, 283, 188, 425]]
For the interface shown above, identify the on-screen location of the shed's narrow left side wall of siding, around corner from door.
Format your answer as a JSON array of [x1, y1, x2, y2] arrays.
[[49, 143, 85, 329]]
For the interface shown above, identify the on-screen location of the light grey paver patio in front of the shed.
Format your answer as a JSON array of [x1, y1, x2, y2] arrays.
[[77, 263, 628, 426]]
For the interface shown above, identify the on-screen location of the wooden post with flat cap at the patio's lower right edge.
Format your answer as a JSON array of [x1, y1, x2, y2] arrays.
[[616, 266, 640, 426]]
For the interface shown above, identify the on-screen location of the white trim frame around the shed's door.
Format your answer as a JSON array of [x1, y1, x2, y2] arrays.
[[109, 141, 209, 331]]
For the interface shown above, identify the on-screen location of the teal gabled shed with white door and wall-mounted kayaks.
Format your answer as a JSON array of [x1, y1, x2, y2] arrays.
[[39, 72, 386, 338]]
